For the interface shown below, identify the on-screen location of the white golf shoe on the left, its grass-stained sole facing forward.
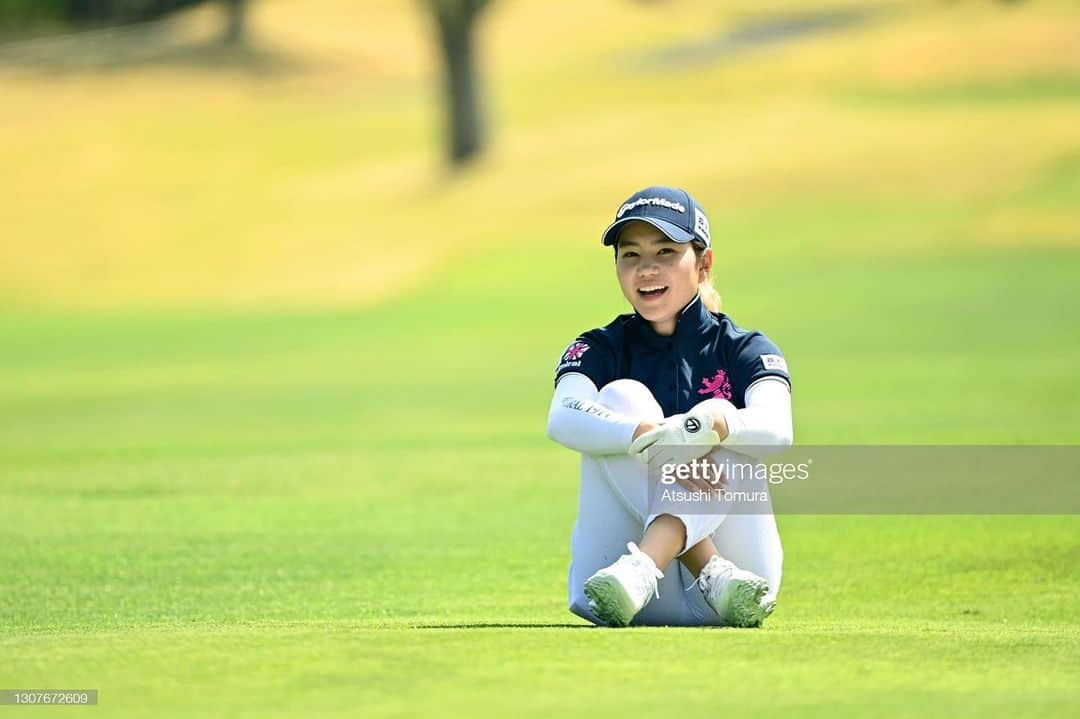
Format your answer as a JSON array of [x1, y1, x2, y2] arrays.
[[585, 542, 664, 626]]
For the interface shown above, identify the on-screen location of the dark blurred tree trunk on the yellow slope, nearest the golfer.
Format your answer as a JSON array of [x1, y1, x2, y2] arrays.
[[427, 0, 489, 166]]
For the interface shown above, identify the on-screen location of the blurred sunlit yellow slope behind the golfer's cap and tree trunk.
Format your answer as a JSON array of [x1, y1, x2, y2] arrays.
[[0, 0, 1080, 306]]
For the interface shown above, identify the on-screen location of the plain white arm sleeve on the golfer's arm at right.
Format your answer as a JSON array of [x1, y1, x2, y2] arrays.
[[703, 377, 795, 459]]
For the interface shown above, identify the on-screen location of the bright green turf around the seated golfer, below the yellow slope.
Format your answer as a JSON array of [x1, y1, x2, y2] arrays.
[[0, 240, 1080, 716]]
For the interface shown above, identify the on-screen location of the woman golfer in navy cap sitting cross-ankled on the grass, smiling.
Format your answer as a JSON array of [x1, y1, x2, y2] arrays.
[[548, 187, 793, 626]]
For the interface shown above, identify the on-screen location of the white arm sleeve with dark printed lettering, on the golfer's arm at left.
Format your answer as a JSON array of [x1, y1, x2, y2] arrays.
[[548, 372, 639, 455]]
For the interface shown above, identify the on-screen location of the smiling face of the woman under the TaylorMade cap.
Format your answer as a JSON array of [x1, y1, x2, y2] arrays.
[[616, 221, 713, 335]]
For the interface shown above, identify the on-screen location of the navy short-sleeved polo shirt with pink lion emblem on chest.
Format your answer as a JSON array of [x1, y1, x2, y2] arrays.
[[555, 295, 792, 417]]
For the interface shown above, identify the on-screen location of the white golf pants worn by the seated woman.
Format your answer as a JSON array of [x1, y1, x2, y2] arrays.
[[569, 379, 784, 626]]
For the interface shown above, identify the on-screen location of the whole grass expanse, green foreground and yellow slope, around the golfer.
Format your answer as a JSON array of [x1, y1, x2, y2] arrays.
[[0, 0, 1080, 718]]
